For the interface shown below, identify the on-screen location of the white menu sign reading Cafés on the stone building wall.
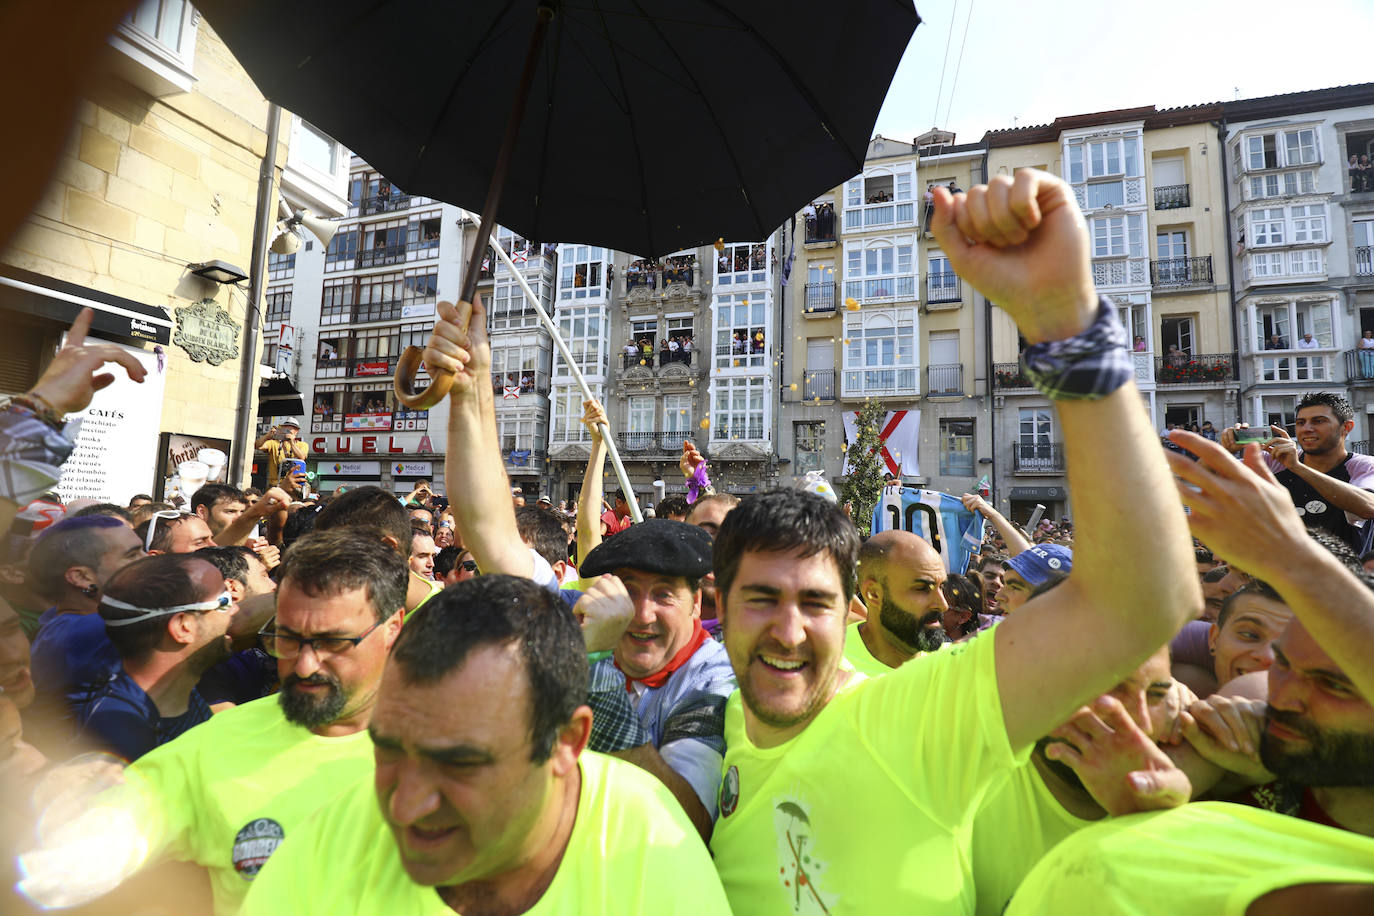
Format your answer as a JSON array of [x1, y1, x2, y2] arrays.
[[58, 343, 166, 505]]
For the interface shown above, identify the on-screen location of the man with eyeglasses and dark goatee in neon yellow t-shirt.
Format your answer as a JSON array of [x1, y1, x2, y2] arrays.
[[14, 529, 409, 913]]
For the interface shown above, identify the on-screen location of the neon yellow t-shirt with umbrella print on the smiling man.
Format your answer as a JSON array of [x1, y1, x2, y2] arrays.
[[710, 631, 1029, 916]]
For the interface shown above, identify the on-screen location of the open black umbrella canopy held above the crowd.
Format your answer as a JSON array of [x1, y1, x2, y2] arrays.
[[196, 0, 921, 255]]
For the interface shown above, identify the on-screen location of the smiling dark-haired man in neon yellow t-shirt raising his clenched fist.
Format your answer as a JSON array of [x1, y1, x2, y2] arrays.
[[710, 170, 1202, 916]]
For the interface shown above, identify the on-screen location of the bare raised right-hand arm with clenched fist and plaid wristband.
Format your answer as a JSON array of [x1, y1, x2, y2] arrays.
[[932, 170, 1202, 748]]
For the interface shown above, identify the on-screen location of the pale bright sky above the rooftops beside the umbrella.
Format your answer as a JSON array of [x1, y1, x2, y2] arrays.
[[875, 0, 1374, 143]]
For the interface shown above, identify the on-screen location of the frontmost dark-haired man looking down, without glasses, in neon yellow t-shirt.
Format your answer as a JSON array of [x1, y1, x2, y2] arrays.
[[243, 575, 730, 916]]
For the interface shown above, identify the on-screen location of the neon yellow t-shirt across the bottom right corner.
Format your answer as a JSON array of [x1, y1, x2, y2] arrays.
[[1007, 802, 1374, 916]]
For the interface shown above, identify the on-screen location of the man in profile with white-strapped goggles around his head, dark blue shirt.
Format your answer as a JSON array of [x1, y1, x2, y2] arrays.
[[78, 553, 234, 761]]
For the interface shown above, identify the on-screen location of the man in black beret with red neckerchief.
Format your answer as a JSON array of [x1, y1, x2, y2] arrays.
[[576, 519, 735, 838]]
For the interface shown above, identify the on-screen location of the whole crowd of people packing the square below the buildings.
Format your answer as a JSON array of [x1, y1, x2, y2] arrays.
[[0, 170, 1374, 916]]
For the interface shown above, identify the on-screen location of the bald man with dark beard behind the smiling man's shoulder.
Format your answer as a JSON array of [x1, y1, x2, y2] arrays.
[[845, 530, 949, 677]]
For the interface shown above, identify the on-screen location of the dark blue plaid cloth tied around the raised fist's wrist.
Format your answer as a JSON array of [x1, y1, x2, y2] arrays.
[[1021, 297, 1135, 401]]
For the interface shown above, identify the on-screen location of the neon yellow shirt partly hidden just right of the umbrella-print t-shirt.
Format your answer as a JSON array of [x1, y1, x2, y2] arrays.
[[973, 761, 1094, 916]]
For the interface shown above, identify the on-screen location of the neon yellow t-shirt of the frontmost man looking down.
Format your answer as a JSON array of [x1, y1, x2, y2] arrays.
[[243, 751, 730, 916]]
